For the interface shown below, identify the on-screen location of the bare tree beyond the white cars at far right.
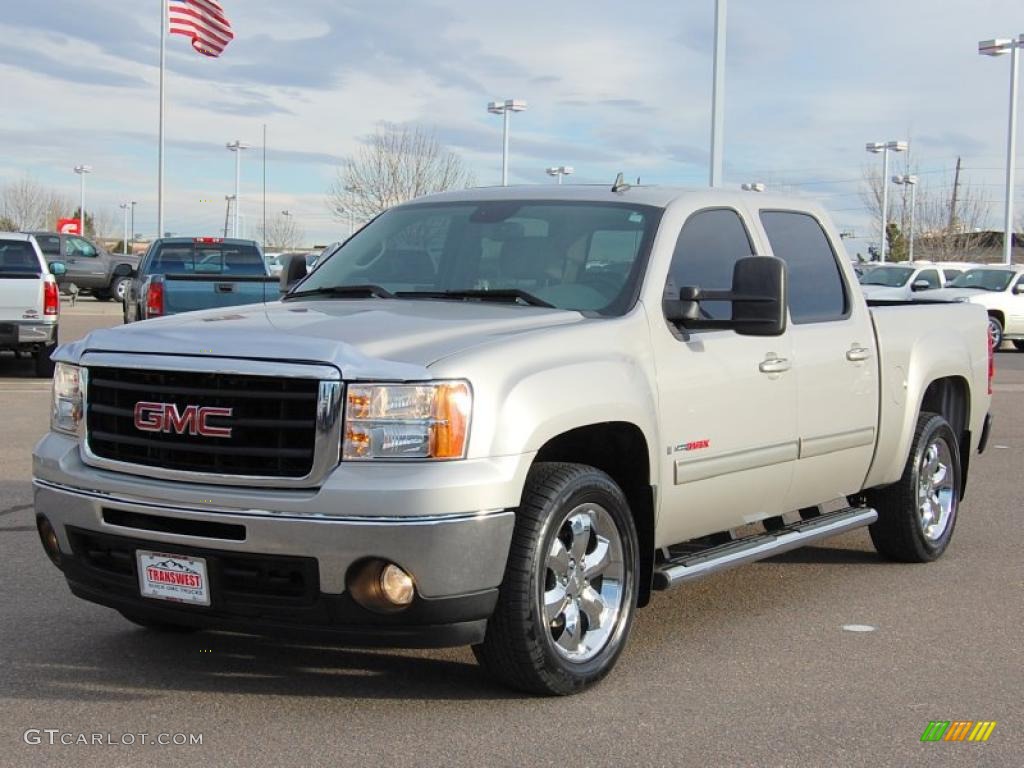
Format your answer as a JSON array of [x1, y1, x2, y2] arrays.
[[860, 163, 990, 261]]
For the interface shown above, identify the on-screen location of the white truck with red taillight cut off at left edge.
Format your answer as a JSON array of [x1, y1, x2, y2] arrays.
[[0, 232, 63, 377]]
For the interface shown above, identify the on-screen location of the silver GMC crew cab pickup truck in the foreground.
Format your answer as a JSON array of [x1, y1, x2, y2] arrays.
[[34, 184, 992, 694]]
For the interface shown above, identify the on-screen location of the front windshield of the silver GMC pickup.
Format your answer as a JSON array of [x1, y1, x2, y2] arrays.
[[296, 201, 660, 314]]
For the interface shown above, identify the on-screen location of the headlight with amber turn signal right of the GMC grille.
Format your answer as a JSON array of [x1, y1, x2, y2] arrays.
[[342, 381, 473, 460]]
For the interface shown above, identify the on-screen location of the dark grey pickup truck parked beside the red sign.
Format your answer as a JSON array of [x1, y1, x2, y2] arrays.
[[30, 231, 138, 301]]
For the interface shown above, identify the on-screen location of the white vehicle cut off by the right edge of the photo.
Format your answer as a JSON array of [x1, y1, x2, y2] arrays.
[[936, 264, 1024, 351]]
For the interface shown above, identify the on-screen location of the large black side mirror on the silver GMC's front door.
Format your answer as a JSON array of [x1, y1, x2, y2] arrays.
[[665, 256, 786, 336]]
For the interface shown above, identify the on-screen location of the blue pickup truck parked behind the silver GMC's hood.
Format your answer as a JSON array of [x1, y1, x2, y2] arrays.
[[124, 238, 281, 323]]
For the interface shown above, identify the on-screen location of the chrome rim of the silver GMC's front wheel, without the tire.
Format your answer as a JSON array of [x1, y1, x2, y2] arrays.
[[541, 503, 625, 662]]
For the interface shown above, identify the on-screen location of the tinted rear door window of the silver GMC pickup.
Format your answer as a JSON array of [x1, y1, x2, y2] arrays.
[[761, 211, 847, 324]]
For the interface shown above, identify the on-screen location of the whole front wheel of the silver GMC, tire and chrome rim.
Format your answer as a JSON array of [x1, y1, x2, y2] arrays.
[[473, 462, 639, 695]]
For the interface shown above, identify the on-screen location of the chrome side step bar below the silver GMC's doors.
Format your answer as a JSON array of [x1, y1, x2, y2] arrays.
[[653, 507, 879, 590]]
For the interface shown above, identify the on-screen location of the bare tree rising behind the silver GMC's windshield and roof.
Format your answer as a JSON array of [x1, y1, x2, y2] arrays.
[[327, 125, 473, 221]]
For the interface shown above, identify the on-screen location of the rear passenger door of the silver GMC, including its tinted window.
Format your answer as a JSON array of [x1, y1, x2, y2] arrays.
[[760, 210, 879, 510]]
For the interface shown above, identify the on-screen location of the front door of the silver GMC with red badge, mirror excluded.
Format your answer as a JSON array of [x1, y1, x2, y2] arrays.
[[648, 208, 798, 547]]
